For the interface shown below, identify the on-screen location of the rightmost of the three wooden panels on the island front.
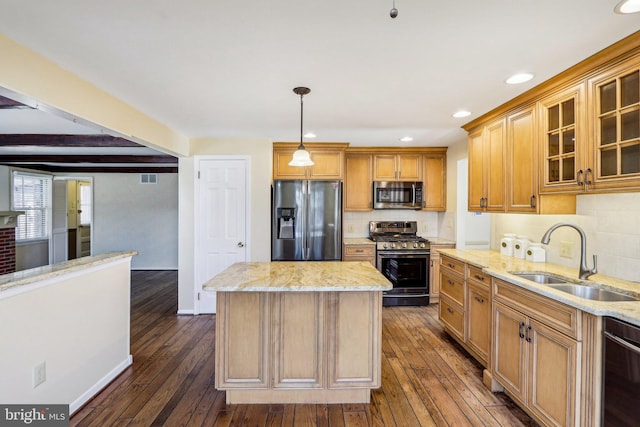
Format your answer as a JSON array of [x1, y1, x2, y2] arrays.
[[327, 292, 382, 389]]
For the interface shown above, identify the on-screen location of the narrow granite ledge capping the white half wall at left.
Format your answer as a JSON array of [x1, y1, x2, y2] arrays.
[[0, 251, 138, 294]]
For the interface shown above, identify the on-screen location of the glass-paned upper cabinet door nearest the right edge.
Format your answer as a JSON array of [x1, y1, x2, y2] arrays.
[[590, 59, 640, 189]]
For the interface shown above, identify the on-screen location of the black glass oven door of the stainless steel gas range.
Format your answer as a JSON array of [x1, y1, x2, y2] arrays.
[[376, 251, 430, 305]]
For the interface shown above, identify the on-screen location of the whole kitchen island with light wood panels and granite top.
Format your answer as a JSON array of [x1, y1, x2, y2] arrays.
[[203, 261, 392, 404]]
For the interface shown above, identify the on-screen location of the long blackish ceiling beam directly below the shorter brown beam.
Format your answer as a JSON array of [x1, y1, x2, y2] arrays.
[[0, 154, 178, 165]]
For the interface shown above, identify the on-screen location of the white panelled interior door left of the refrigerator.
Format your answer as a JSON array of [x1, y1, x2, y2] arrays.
[[195, 157, 248, 314]]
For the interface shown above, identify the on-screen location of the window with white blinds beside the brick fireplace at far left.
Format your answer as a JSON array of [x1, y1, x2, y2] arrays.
[[13, 172, 51, 241]]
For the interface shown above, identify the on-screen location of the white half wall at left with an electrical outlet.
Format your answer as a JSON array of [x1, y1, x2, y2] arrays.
[[0, 257, 131, 412]]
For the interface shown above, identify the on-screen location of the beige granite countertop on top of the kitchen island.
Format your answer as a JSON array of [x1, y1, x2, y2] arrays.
[[202, 261, 393, 292]]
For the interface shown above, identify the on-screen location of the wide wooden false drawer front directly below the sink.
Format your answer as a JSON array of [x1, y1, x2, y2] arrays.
[[493, 278, 582, 341]]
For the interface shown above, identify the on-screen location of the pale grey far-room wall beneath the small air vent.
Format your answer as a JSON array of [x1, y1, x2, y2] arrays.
[[92, 173, 178, 270]]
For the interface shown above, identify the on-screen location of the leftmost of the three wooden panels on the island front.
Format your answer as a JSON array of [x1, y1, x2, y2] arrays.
[[215, 292, 270, 389]]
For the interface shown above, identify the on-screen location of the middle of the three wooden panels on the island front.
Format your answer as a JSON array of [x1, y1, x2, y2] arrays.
[[271, 292, 325, 389]]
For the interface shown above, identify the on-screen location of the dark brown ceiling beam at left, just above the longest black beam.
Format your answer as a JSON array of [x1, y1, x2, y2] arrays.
[[0, 134, 144, 147]]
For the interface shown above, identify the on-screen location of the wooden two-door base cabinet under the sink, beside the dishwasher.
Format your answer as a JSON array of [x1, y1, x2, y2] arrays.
[[492, 279, 581, 426]]
